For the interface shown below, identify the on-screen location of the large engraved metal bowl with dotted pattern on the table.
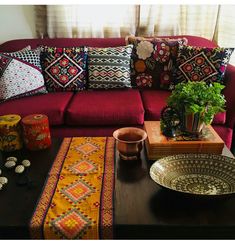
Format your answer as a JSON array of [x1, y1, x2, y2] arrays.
[[150, 154, 235, 196]]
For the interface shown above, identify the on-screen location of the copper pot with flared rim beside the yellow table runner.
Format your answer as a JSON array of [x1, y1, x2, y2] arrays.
[[113, 127, 147, 160]]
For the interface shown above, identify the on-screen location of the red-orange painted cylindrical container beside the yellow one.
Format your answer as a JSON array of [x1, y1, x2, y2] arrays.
[[21, 114, 51, 151]]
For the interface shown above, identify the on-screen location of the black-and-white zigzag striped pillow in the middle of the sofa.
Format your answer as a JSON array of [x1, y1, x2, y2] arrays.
[[88, 45, 133, 89]]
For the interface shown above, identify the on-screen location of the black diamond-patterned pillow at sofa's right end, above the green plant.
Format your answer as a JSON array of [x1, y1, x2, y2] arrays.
[[172, 46, 234, 87]]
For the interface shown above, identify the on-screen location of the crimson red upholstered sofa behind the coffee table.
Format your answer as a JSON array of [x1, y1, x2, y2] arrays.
[[0, 36, 235, 151]]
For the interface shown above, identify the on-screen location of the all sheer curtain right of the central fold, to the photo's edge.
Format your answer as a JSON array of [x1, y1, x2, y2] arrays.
[[137, 5, 235, 65]]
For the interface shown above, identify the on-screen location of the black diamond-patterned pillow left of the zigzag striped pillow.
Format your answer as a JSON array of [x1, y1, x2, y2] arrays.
[[41, 47, 87, 92]]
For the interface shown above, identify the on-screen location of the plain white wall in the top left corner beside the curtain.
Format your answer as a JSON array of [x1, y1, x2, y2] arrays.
[[0, 5, 36, 44]]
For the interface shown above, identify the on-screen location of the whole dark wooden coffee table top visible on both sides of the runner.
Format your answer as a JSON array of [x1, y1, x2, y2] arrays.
[[0, 139, 235, 239]]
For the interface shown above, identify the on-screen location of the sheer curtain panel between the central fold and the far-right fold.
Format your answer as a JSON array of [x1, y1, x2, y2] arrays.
[[139, 5, 219, 39]]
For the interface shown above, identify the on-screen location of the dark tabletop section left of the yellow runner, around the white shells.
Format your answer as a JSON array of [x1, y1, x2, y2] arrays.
[[0, 139, 62, 239]]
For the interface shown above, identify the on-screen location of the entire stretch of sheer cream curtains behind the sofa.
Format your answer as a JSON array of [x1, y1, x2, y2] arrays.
[[35, 4, 235, 64]]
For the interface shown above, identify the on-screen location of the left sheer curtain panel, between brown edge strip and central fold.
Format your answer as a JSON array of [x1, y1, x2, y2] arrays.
[[44, 5, 138, 37]]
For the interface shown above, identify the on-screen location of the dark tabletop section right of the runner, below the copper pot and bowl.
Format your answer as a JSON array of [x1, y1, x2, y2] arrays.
[[114, 147, 235, 239]]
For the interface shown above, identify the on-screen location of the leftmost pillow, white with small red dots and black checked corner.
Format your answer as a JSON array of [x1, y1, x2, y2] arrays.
[[0, 48, 47, 102]]
